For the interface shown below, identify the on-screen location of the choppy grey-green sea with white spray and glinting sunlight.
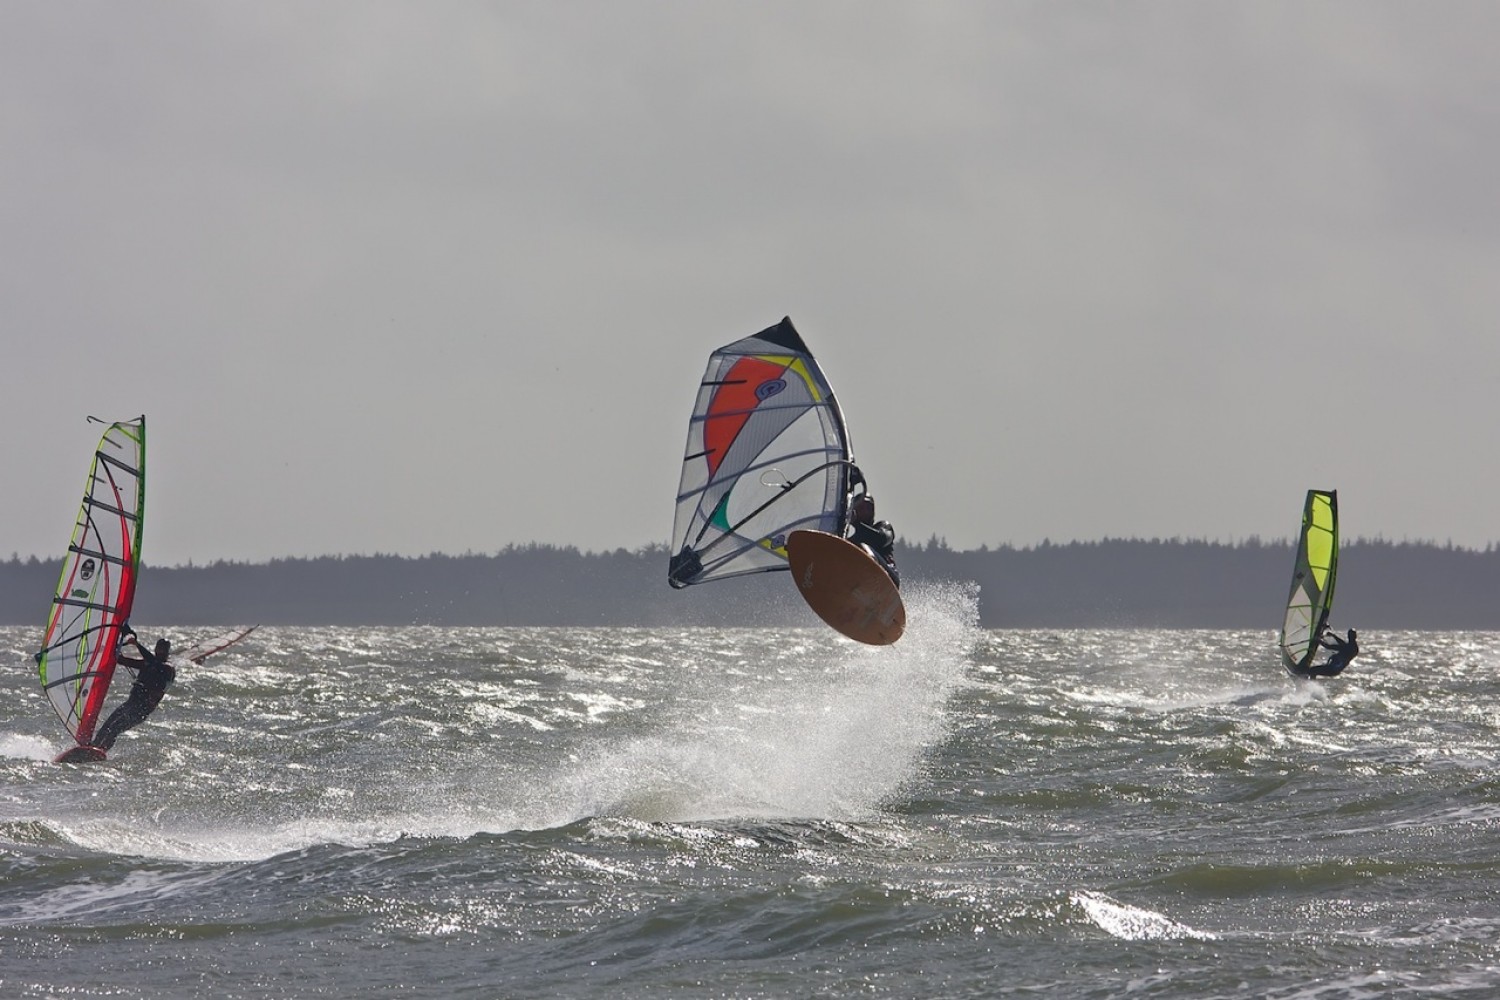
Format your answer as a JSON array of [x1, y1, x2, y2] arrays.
[[0, 588, 1500, 1000]]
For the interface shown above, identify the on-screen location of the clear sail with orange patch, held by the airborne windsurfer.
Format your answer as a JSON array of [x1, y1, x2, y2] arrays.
[[668, 318, 851, 588]]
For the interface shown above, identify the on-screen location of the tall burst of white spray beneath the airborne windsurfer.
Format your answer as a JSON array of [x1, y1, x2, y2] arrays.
[[504, 586, 978, 828]]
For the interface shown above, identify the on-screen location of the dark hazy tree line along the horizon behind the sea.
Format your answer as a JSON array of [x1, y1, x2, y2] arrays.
[[0, 537, 1500, 630]]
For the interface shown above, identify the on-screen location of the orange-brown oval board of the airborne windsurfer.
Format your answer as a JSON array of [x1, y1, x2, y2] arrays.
[[786, 531, 906, 646]]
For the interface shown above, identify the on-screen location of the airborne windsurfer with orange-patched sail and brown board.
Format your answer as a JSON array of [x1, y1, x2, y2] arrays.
[[668, 318, 906, 646]]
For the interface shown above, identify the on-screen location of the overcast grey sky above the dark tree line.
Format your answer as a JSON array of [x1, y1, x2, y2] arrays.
[[0, 0, 1500, 565]]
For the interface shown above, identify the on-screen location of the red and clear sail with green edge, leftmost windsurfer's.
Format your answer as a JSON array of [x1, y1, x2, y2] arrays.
[[36, 417, 146, 744]]
